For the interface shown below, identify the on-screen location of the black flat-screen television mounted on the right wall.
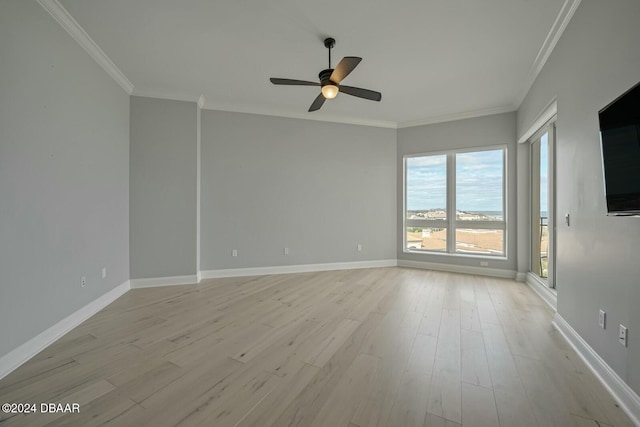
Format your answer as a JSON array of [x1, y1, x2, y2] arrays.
[[599, 83, 640, 215]]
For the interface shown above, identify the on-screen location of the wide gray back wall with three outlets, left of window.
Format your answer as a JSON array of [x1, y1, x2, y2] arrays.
[[201, 110, 396, 270]]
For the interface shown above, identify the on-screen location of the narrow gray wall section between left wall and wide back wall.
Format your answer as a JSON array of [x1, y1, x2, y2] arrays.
[[130, 96, 197, 279]]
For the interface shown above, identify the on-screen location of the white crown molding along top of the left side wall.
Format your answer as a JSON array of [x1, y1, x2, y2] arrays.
[[38, 0, 133, 95]]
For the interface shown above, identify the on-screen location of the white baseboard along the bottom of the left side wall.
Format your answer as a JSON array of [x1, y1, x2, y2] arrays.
[[0, 280, 131, 379]]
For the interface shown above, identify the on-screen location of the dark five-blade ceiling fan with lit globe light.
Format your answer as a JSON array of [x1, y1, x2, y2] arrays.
[[269, 37, 382, 112]]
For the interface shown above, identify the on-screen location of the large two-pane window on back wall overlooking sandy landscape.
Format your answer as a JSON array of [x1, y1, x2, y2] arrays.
[[404, 148, 506, 257]]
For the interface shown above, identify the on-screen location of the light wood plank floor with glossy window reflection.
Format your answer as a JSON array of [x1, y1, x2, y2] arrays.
[[0, 268, 632, 427]]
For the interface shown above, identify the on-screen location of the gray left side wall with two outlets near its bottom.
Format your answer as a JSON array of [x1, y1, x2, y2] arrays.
[[0, 0, 129, 356]]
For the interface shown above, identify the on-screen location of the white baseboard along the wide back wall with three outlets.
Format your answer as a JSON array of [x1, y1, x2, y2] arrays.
[[200, 259, 398, 279]]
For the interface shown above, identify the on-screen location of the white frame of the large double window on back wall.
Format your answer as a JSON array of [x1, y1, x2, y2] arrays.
[[401, 144, 509, 260]]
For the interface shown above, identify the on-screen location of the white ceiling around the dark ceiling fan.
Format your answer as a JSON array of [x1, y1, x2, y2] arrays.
[[60, 0, 575, 126]]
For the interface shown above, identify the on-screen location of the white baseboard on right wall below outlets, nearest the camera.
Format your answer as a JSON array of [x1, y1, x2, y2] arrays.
[[553, 313, 640, 426]]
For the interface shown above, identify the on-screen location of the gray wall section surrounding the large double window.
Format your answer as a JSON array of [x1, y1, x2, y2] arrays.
[[396, 113, 517, 271]]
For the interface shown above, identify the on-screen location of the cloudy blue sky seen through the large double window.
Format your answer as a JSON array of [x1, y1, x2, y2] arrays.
[[407, 150, 503, 211]]
